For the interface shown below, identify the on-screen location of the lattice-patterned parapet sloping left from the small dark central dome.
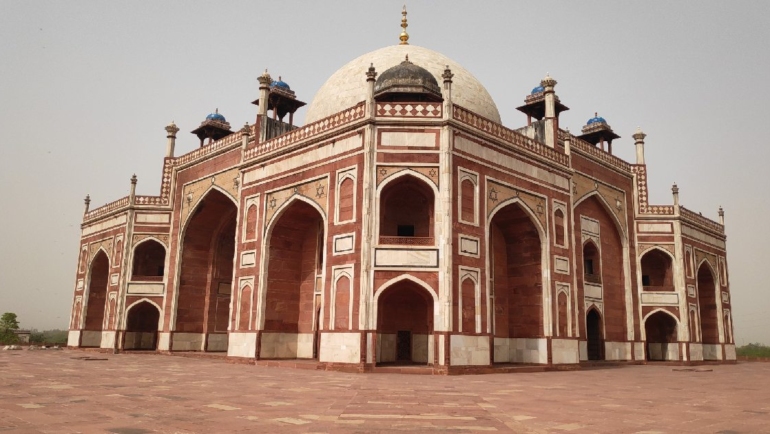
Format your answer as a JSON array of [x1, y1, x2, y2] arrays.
[[243, 101, 366, 161]]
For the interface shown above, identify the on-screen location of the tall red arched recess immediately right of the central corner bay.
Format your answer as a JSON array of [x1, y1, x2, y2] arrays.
[[482, 202, 544, 363]]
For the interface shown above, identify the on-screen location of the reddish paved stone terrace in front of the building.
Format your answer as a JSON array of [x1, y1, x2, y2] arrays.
[[0, 350, 770, 434]]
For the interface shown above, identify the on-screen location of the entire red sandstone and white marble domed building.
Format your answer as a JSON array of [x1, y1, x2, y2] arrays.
[[69, 37, 735, 373]]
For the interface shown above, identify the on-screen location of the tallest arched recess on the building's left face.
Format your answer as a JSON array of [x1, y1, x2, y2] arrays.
[[172, 189, 237, 351]]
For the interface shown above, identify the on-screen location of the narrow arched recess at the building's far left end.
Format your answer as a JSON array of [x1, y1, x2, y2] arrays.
[[81, 250, 110, 347]]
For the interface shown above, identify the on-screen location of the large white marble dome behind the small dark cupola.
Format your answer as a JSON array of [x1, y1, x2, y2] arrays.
[[305, 45, 500, 124]]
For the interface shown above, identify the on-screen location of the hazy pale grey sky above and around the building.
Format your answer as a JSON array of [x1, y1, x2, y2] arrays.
[[0, 0, 770, 343]]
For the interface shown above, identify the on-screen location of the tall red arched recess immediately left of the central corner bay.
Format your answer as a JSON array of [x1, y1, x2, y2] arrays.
[[259, 200, 325, 359]]
